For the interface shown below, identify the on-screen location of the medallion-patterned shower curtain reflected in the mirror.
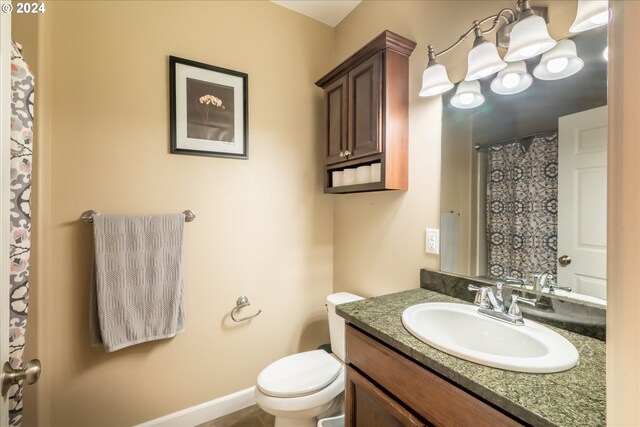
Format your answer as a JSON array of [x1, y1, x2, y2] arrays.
[[487, 132, 558, 284]]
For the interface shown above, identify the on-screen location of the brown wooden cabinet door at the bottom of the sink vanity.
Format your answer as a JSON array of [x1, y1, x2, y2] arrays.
[[345, 366, 425, 427]]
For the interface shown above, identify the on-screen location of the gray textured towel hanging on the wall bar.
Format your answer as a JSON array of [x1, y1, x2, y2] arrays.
[[90, 214, 184, 352]]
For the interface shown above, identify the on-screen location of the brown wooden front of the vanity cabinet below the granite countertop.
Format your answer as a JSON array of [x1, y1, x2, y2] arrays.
[[345, 325, 522, 427]]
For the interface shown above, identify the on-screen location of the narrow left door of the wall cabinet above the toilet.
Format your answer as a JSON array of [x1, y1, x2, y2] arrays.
[[324, 76, 348, 165]]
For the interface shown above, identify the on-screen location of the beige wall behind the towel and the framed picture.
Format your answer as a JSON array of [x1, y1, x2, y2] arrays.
[[25, 1, 333, 427]]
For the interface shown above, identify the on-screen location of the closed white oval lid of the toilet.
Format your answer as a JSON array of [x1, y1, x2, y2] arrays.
[[258, 350, 342, 397]]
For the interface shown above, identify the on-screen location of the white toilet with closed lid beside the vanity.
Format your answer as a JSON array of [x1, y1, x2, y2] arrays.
[[255, 292, 363, 427]]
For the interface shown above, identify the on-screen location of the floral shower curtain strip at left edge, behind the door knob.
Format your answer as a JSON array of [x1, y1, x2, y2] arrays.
[[9, 42, 34, 426]]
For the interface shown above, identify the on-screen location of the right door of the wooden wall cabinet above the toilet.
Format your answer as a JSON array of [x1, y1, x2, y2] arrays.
[[348, 52, 382, 159]]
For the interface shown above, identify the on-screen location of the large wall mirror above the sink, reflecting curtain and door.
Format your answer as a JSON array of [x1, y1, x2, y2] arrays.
[[441, 26, 607, 305]]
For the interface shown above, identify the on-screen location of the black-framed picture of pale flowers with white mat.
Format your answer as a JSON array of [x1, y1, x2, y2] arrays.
[[169, 56, 249, 159]]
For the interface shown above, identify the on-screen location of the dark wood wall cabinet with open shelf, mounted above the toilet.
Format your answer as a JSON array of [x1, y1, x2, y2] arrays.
[[316, 31, 416, 193]]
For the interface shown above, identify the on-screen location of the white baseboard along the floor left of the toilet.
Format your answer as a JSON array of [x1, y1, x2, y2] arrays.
[[134, 387, 256, 427]]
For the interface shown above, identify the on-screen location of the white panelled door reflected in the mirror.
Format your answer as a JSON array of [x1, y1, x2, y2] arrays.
[[558, 106, 607, 299]]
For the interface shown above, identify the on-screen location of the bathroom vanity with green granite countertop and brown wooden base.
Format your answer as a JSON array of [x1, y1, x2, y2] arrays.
[[337, 289, 606, 427]]
